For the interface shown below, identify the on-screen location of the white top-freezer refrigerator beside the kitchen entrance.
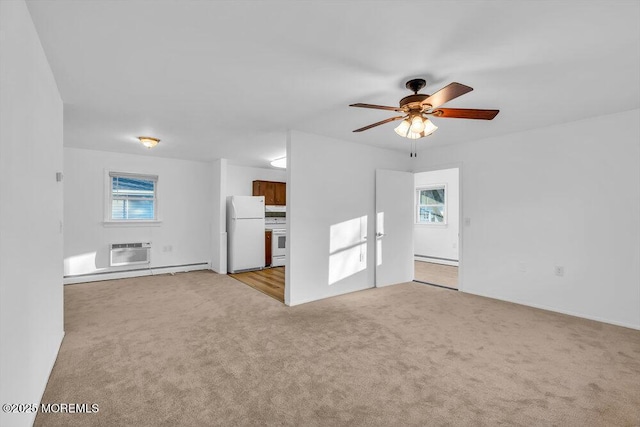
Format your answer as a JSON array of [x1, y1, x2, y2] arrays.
[[227, 196, 265, 273]]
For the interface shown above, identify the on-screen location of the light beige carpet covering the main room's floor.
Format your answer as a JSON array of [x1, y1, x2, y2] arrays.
[[35, 272, 640, 426]]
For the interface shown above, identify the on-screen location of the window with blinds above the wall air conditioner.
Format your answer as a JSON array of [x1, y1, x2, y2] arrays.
[[108, 172, 158, 221]]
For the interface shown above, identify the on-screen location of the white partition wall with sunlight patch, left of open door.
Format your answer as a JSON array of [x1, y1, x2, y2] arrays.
[[285, 131, 409, 305]]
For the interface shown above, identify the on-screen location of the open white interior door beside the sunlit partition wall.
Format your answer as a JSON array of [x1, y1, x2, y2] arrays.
[[376, 169, 414, 287]]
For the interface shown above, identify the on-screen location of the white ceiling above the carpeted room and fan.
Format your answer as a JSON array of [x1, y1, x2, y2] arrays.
[[27, 0, 640, 167]]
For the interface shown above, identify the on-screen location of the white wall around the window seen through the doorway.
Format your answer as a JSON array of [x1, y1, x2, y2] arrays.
[[413, 168, 460, 262]]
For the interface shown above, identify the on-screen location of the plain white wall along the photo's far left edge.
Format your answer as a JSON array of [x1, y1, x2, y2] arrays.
[[0, 1, 64, 426]]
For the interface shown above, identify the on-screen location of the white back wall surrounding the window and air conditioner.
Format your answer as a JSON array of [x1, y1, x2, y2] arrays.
[[64, 147, 213, 276]]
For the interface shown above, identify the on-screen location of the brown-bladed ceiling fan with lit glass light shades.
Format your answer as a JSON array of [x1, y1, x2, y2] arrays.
[[349, 79, 500, 155]]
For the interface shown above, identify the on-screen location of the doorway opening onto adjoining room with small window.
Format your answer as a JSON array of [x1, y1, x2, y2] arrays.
[[413, 167, 460, 290]]
